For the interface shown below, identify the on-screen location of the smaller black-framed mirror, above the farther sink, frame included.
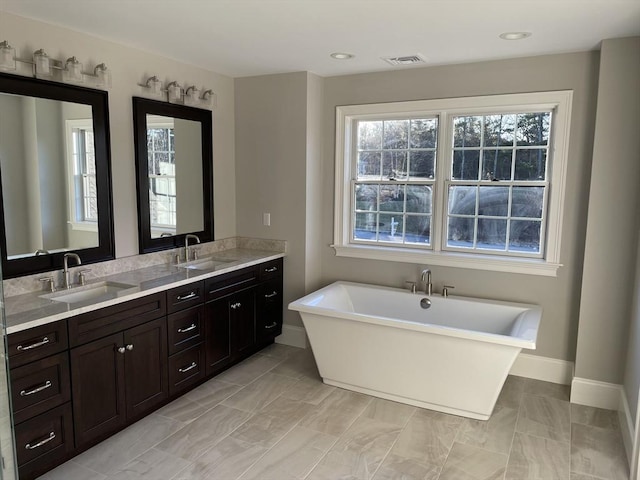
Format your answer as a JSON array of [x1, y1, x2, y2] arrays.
[[133, 97, 214, 253]]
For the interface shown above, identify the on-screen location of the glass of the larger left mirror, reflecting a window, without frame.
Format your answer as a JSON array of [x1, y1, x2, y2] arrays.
[[0, 93, 99, 259]]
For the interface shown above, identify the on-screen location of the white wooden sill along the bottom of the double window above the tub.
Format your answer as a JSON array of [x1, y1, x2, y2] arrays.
[[331, 245, 562, 277]]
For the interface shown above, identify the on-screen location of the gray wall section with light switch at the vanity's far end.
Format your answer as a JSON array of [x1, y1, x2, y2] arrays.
[[235, 72, 308, 325]]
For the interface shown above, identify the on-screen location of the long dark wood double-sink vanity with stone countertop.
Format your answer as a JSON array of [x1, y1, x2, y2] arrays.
[[7, 252, 284, 479]]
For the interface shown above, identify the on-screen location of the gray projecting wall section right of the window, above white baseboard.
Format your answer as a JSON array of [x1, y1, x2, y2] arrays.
[[575, 37, 640, 382]]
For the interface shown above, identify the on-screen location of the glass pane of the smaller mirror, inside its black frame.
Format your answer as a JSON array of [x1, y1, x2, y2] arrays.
[[147, 115, 204, 238]]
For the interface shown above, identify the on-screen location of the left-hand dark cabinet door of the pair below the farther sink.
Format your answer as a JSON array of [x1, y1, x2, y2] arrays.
[[205, 297, 231, 375]]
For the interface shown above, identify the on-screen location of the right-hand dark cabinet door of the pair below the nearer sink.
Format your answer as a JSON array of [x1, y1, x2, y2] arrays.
[[124, 318, 169, 419]]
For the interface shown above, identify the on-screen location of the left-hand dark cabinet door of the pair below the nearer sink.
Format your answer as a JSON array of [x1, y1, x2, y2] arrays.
[[71, 333, 126, 447]]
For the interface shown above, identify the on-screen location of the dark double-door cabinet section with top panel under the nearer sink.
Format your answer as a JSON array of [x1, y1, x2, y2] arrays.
[[69, 294, 169, 448]]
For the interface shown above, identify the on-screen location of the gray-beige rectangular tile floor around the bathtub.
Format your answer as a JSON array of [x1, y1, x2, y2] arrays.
[[41, 345, 629, 480]]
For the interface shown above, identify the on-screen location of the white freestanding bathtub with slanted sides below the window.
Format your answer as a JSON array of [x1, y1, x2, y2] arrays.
[[289, 282, 542, 420]]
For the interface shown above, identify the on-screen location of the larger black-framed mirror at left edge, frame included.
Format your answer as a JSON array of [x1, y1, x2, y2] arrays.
[[0, 74, 115, 278]]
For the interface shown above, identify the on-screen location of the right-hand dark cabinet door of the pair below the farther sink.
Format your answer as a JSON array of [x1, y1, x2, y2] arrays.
[[229, 287, 256, 360]]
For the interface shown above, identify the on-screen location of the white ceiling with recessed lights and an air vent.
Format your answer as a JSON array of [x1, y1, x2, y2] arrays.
[[0, 0, 640, 77]]
